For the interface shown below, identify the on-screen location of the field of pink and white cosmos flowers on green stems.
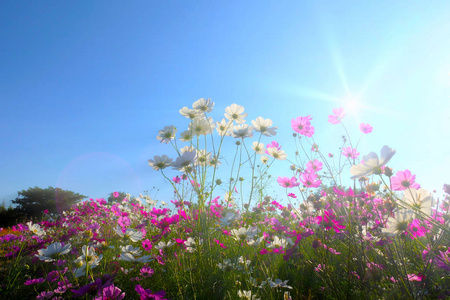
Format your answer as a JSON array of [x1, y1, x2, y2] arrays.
[[0, 98, 450, 300]]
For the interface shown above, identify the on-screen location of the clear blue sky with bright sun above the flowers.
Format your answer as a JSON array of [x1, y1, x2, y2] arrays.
[[0, 1, 450, 204]]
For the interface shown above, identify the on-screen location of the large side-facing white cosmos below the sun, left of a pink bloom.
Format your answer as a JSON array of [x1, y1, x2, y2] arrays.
[[350, 145, 395, 179]]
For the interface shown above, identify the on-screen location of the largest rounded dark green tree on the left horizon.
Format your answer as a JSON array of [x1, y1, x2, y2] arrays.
[[12, 187, 86, 219]]
